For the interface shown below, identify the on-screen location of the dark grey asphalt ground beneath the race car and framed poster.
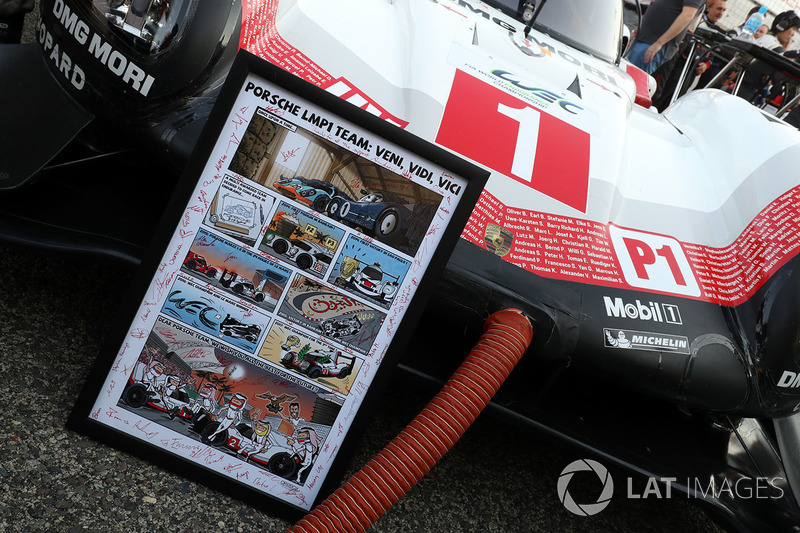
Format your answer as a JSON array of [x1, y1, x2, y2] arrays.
[[0, 4, 719, 533]]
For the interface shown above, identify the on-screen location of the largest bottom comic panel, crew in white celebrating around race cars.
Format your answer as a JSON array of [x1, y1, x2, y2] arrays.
[[117, 316, 342, 485]]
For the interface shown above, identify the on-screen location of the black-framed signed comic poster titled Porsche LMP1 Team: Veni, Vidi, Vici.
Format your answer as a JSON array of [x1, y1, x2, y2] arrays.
[[70, 52, 488, 516]]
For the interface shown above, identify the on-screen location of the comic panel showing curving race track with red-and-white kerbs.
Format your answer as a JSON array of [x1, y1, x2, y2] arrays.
[[278, 275, 386, 355]]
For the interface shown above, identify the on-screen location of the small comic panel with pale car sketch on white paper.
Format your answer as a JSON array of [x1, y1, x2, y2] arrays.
[[203, 176, 275, 246]]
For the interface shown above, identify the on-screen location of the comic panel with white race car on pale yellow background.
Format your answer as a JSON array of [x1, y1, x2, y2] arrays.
[[258, 322, 362, 395]]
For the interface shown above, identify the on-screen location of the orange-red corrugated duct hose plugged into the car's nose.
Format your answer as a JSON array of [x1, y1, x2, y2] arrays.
[[288, 309, 533, 533]]
